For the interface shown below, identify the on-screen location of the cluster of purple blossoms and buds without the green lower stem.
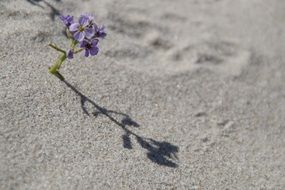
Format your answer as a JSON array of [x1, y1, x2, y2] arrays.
[[60, 14, 107, 59]]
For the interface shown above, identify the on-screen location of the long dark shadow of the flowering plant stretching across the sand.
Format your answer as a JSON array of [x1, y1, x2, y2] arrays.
[[62, 80, 179, 167]]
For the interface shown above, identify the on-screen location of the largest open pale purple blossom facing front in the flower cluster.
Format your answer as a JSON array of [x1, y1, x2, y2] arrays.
[[69, 15, 95, 42]]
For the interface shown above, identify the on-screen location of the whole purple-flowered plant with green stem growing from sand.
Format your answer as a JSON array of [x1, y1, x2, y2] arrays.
[[49, 14, 107, 80]]
